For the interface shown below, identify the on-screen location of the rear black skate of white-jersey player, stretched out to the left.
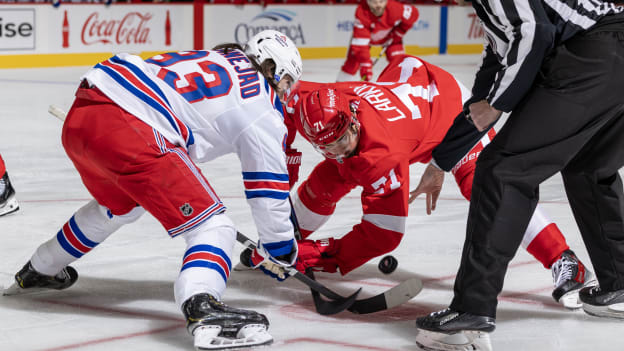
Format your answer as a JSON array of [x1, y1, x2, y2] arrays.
[[2, 261, 78, 296]]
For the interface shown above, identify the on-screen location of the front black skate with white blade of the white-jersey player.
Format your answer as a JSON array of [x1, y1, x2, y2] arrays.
[[182, 293, 273, 350]]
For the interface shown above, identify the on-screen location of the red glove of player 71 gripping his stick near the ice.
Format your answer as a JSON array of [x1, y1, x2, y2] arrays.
[[295, 238, 340, 273]]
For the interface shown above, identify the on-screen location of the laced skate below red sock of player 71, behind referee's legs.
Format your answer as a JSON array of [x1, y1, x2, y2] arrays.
[[551, 250, 595, 309]]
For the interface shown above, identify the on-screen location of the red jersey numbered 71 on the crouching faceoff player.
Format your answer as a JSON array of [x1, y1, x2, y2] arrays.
[[287, 56, 462, 274]]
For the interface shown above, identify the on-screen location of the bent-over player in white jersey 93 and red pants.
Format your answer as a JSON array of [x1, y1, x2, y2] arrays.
[[7, 30, 302, 349]]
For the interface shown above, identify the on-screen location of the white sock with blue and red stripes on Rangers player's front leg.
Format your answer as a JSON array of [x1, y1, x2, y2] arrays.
[[174, 214, 236, 307]]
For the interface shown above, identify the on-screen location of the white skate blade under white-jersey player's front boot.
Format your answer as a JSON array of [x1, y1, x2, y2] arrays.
[[193, 324, 273, 350]]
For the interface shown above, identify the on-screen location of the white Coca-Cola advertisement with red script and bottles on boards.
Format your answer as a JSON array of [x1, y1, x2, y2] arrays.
[[58, 6, 184, 52]]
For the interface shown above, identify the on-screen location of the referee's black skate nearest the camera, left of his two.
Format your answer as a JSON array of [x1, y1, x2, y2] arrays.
[[416, 308, 496, 351]]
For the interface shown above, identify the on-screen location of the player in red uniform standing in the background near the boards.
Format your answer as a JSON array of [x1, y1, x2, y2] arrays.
[[337, 0, 418, 81]]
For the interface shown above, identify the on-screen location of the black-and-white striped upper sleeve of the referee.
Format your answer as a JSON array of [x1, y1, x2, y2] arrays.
[[473, 0, 555, 112]]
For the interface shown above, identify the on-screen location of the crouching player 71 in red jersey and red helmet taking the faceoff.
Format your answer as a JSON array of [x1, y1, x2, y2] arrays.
[[287, 56, 592, 308]]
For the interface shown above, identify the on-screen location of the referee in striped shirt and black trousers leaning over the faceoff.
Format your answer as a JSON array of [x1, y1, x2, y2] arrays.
[[416, 0, 624, 350]]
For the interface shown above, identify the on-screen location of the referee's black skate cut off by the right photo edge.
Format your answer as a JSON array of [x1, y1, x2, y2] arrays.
[[579, 286, 624, 319]]
